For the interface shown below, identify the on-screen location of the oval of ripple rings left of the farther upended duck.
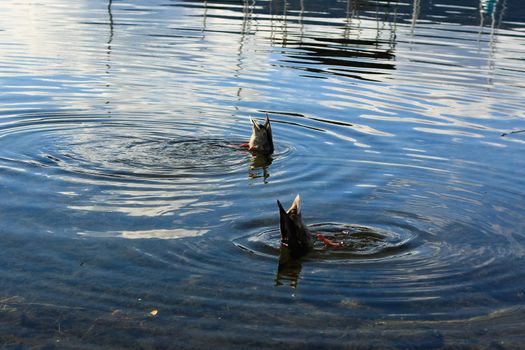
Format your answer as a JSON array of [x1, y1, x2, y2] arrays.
[[2, 116, 256, 179]]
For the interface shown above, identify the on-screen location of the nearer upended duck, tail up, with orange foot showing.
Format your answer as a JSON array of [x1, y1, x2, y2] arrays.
[[277, 195, 340, 259]]
